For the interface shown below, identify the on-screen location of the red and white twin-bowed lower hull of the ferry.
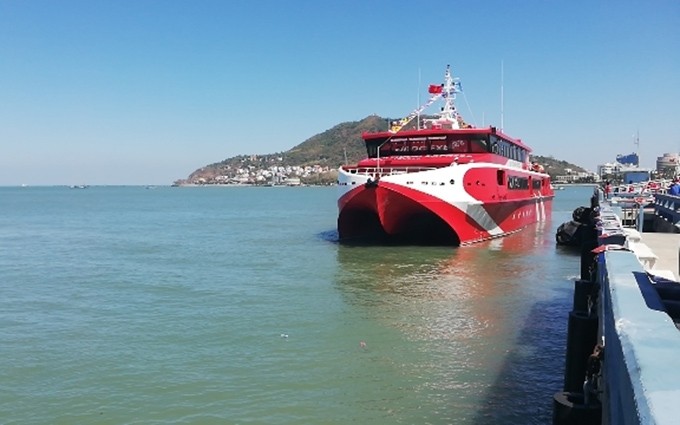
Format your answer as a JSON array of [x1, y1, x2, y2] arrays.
[[338, 163, 553, 245]]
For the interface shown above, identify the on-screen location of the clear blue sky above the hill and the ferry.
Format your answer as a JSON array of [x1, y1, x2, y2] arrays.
[[0, 0, 680, 185]]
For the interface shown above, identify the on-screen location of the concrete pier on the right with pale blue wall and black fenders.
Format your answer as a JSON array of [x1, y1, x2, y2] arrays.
[[553, 193, 680, 425]]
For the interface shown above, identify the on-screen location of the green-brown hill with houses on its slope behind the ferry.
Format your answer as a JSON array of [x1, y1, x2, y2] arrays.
[[175, 115, 585, 184]]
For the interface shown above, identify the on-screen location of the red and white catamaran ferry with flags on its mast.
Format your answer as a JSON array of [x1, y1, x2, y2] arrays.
[[338, 66, 554, 245]]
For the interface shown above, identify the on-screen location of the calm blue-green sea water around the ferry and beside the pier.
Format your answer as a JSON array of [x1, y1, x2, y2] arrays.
[[0, 187, 591, 425]]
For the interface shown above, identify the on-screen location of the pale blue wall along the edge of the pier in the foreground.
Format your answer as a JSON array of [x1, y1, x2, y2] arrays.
[[598, 251, 680, 425]]
